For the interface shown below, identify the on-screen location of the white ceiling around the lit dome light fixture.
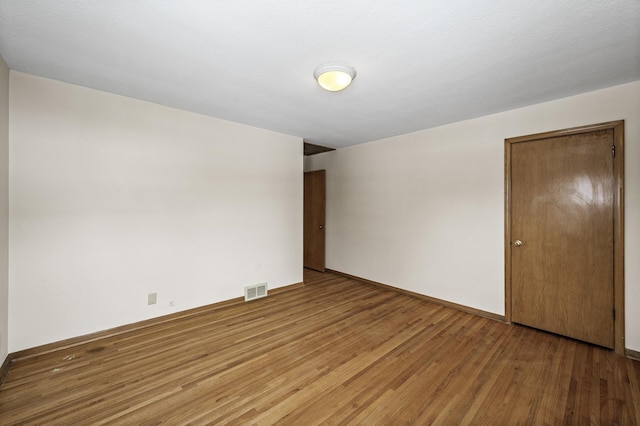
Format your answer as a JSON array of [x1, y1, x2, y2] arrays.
[[0, 0, 640, 148]]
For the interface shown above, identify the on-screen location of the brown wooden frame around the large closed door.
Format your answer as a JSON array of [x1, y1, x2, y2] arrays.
[[504, 120, 625, 356]]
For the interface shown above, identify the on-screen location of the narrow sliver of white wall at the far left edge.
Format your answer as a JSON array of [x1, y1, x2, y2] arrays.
[[0, 56, 9, 365]]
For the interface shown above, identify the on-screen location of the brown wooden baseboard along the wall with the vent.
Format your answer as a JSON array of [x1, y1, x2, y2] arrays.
[[9, 282, 304, 364]]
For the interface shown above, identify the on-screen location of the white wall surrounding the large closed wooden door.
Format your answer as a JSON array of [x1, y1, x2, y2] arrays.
[[305, 82, 640, 351]]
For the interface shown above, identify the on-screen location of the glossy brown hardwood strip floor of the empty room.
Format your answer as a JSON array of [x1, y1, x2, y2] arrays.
[[0, 271, 640, 425]]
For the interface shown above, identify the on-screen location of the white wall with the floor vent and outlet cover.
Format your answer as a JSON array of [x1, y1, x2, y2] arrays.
[[9, 71, 303, 352]]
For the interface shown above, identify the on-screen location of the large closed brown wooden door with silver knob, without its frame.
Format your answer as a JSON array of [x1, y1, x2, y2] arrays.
[[510, 125, 615, 348]]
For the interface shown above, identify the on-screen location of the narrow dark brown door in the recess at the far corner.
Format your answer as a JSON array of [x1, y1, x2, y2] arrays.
[[304, 170, 325, 272]]
